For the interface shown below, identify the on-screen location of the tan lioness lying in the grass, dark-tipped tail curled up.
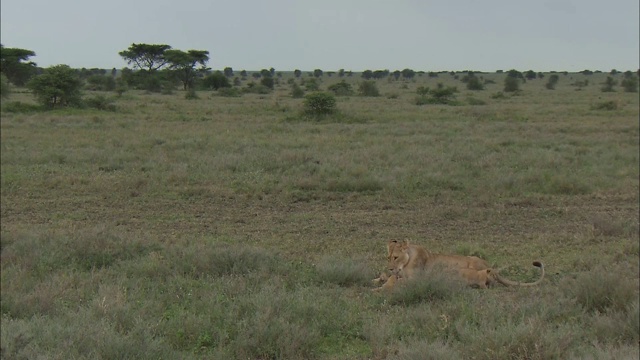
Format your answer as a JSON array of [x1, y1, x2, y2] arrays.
[[383, 240, 544, 288]]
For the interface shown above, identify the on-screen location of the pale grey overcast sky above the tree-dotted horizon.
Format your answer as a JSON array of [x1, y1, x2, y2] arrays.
[[0, 0, 640, 71]]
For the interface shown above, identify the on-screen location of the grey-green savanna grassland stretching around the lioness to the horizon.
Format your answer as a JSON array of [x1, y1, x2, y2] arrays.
[[0, 74, 640, 359]]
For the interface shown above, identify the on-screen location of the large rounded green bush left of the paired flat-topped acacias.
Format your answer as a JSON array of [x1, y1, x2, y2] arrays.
[[27, 65, 82, 108]]
